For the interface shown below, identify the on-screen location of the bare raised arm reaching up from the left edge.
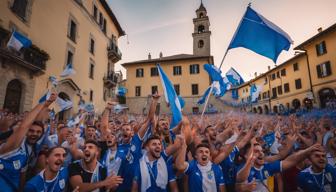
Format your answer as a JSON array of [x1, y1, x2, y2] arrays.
[[0, 93, 57, 154]]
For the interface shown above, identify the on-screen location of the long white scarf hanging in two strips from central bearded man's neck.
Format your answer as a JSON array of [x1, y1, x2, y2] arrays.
[[140, 154, 168, 192]]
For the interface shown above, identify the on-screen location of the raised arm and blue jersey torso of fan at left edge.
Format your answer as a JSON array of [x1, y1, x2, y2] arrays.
[[0, 93, 57, 192]]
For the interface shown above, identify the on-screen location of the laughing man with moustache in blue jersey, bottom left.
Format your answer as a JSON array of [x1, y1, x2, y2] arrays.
[[23, 147, 68, 192]]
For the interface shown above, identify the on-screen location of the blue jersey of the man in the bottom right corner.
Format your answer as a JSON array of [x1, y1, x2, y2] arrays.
[[297, 164, 336, 192]]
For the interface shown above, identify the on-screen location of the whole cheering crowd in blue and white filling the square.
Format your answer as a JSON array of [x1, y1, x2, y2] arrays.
[[0, 93, 336, 192]]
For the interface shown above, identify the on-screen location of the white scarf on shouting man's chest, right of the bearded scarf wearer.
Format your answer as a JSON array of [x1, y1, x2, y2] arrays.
[[197, 161, 217, 192]]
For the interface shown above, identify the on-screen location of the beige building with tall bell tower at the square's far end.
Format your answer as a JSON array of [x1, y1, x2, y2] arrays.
[[122, 3, 228, 114]]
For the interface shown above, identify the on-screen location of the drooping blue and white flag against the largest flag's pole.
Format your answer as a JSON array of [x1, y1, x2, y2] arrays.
[[203, 64, 227, 97]]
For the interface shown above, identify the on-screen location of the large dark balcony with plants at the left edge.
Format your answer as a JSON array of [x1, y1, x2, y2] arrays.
[[0, 28, 49, 74]]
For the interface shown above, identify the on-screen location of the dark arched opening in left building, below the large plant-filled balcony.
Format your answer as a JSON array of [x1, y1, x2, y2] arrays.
[[3, 79, 22, 113]]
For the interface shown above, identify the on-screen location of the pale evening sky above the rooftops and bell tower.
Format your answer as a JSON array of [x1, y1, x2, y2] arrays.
[[108, 0, 336, 81]]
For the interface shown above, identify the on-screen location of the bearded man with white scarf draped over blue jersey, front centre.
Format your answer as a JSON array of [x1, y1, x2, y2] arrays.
[[132, 135, 177, 192]]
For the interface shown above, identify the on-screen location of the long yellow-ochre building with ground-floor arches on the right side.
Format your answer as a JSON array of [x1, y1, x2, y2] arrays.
[[231, 24, 336, 114]]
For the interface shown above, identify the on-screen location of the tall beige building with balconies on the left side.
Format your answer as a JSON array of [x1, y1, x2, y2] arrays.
[[0, 0, 125, 118]]
